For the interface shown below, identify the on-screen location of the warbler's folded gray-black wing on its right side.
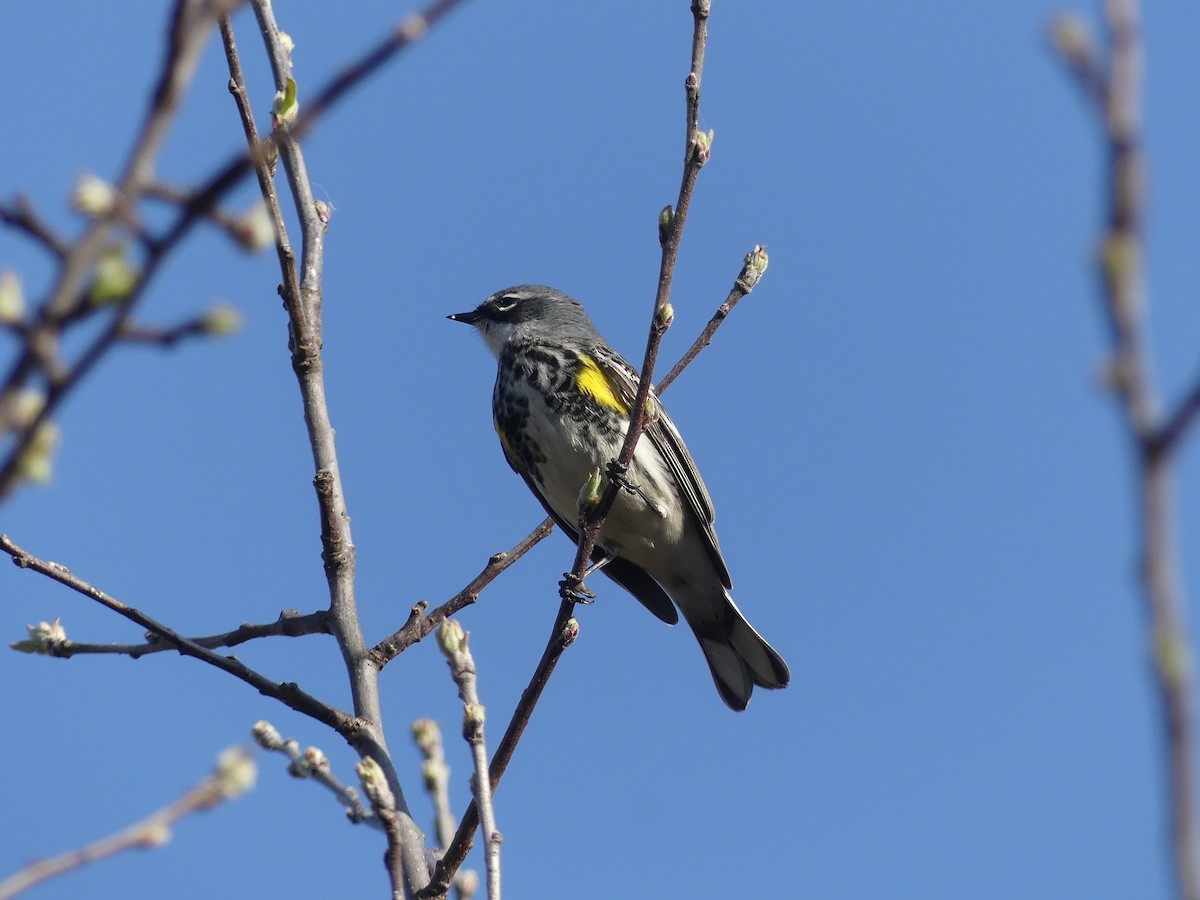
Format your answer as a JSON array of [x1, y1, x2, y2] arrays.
[[595, 349, 733, 588]]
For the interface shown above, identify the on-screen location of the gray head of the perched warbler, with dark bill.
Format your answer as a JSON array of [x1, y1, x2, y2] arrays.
[[448, 284, 599, 356]]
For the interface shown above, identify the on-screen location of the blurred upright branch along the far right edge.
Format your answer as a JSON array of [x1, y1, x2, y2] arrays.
[[1051, 0, 1200, 900]]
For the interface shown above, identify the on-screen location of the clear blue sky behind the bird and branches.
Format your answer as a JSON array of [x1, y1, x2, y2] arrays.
[[0, 0, 1200, 900]]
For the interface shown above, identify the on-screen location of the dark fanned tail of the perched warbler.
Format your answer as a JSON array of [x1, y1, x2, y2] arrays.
[[679, 590, 792, 710]]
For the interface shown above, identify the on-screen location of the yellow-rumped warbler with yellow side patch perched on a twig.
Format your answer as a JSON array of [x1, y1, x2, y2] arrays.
[[450, 284, 791, 709]]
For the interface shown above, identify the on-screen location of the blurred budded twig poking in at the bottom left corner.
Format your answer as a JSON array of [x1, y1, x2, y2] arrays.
[[0, 748, 256, 900]]
